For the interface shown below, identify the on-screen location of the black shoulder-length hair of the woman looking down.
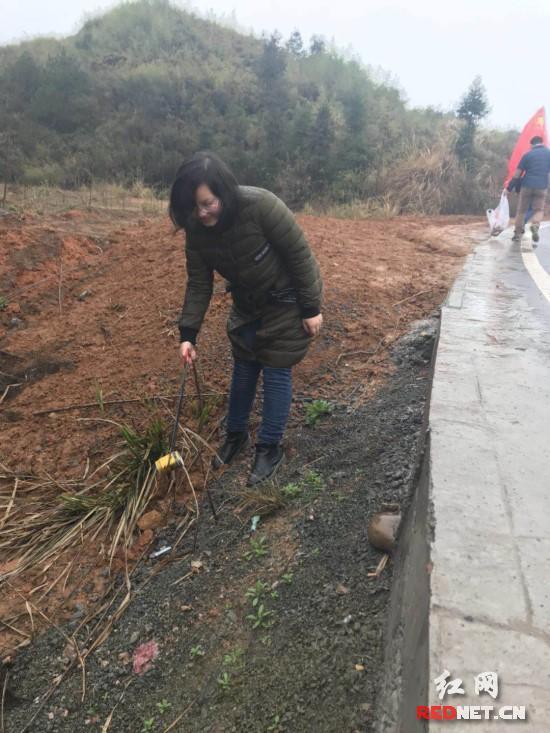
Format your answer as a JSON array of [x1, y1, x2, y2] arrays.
[[168, 151, 239, 229]]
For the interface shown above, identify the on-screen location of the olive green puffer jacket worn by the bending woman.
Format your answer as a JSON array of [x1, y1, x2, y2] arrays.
[[179, 186, 322, 367]]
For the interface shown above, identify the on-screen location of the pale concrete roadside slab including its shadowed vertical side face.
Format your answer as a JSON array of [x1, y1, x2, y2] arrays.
[[375, 227, 550, 733]]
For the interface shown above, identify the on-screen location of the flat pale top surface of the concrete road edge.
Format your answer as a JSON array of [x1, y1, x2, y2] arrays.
[[428, 227, 550, 733]]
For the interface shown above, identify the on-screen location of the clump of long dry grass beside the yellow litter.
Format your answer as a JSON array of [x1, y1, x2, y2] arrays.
[[0, 418, 203, 581]]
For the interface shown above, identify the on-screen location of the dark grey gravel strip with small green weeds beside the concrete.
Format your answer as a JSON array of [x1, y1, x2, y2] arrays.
[[4, 317, 437, 733]]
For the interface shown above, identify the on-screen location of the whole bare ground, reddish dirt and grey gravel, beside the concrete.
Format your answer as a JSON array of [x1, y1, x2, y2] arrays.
[[0, 207, 486, 733]]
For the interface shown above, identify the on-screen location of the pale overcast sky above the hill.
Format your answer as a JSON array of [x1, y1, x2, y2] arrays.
[[0, 0, 550, 127]]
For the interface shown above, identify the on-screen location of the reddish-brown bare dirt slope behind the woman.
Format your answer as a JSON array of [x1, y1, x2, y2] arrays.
[[0, 212, 475, 475]]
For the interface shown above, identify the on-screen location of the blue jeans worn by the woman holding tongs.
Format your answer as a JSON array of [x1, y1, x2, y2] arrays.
[[227, 321, 292, 445]]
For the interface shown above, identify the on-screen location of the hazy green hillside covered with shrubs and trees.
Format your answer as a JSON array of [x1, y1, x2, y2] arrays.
[[0, 0, 511, 213]]
